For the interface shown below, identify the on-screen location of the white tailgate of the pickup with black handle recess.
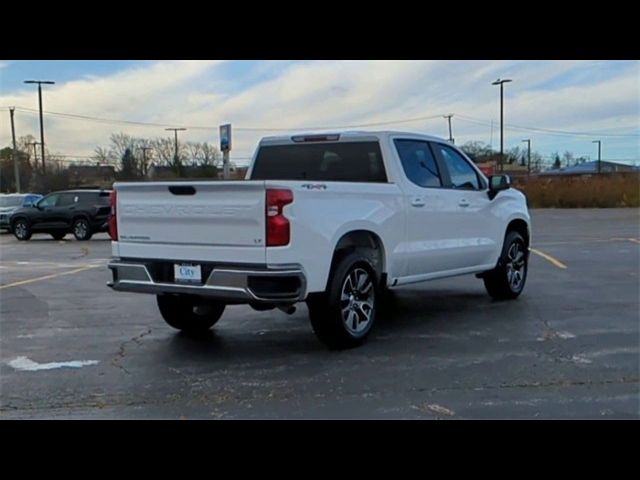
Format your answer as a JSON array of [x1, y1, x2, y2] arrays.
[[115, 181, 265, 263]]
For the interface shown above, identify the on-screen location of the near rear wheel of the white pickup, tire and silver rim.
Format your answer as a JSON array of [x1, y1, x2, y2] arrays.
[[307, 251, 380, 349]]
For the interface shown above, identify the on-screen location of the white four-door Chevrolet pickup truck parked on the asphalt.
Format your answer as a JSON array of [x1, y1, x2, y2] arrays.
[[109, 132, 531, 348]]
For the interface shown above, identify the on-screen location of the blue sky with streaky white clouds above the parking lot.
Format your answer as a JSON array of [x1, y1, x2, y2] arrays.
[[0, 60, 640, 164]]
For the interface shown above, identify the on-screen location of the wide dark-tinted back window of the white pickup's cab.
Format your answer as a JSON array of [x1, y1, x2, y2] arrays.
[[251, 142, 387, 183]]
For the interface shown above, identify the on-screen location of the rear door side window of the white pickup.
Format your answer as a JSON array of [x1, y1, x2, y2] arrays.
[[394, 139, 442, 187]]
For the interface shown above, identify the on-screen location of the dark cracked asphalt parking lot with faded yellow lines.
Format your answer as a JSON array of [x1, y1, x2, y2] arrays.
[[0, 209, 640, 419]]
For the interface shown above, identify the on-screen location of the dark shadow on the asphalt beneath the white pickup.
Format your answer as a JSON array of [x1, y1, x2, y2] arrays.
[[160, 290, 498, 362]]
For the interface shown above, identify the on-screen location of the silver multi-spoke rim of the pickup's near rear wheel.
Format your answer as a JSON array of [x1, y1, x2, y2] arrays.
[[340, 268, 375, 336]]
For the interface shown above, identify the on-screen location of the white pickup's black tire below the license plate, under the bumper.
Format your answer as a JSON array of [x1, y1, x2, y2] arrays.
[[157, 295, 225, 333]]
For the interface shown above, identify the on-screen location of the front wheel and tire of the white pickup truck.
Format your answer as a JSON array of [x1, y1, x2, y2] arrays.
[[483, 231, 529, 300]]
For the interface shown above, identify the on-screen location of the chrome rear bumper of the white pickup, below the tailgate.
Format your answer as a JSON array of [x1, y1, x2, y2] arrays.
[[107, 259, 306, 303]]
